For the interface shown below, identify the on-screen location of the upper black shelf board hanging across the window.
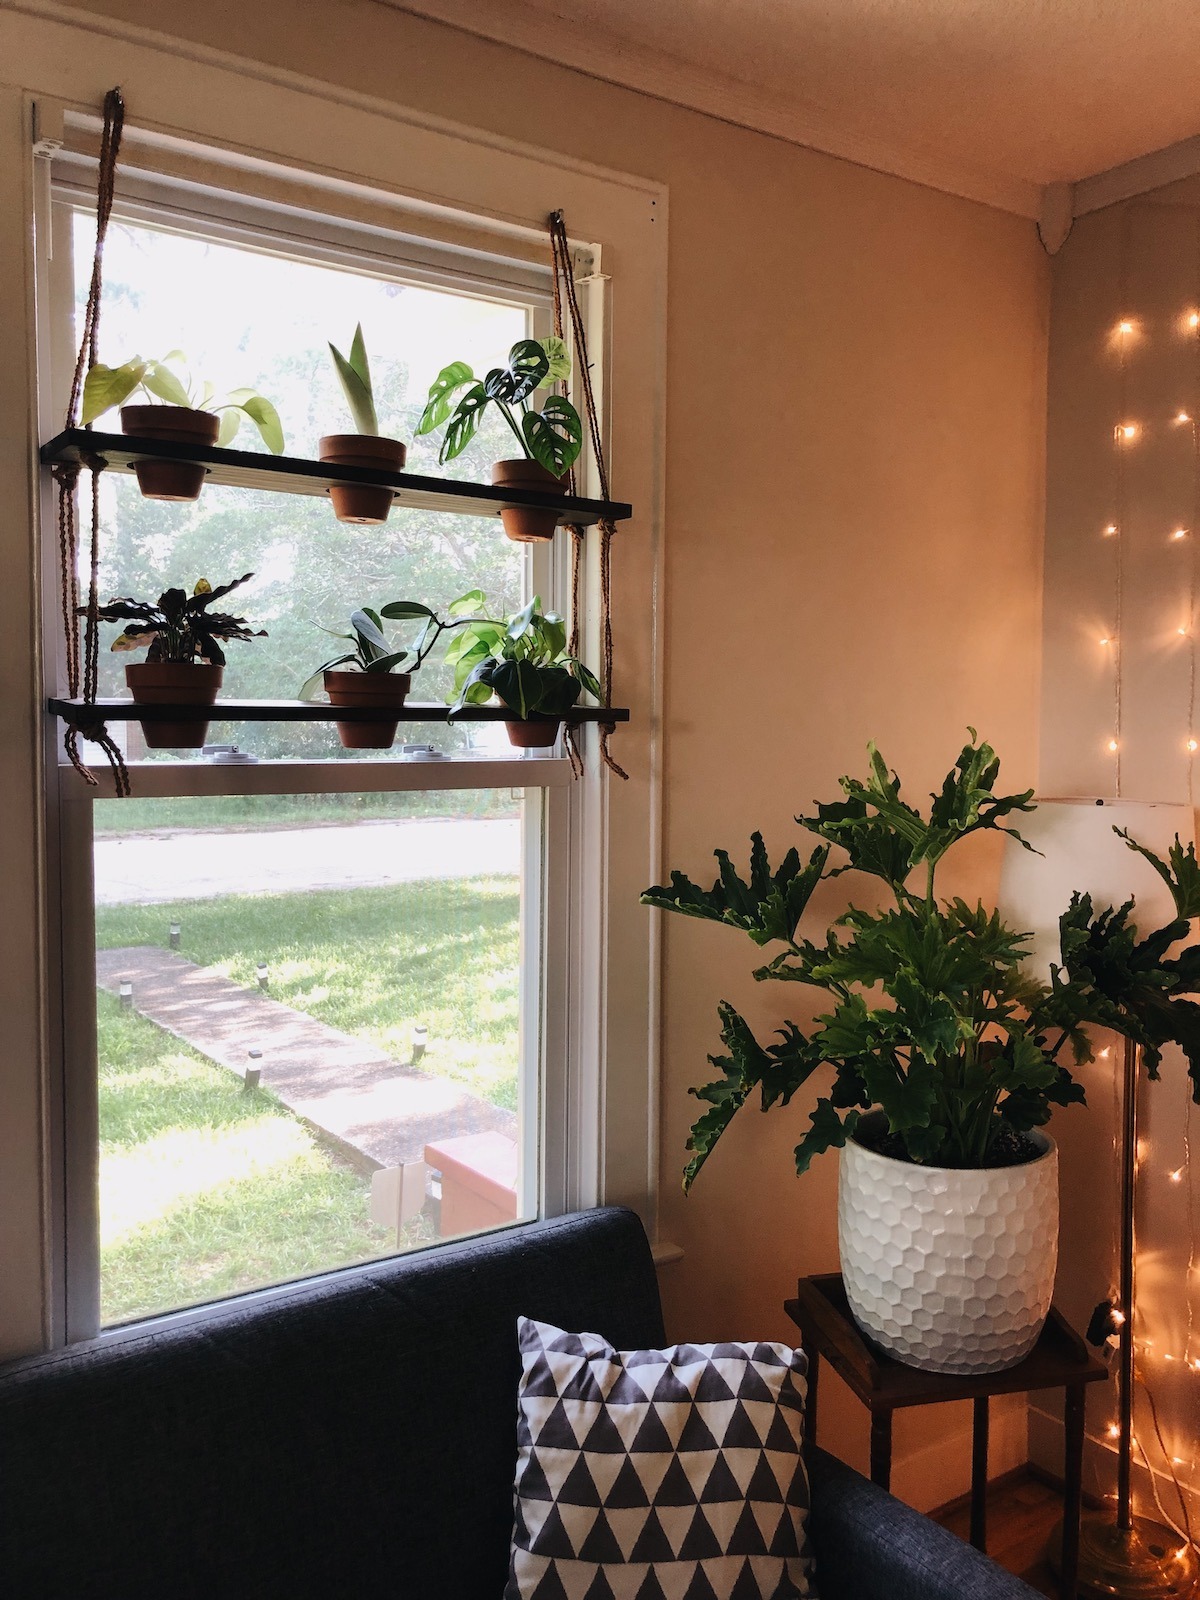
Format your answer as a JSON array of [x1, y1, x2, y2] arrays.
[[42, 427, 634, 526]]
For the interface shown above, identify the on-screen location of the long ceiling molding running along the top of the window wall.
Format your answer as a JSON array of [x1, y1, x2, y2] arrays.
[[379, 0, 1042, 219]]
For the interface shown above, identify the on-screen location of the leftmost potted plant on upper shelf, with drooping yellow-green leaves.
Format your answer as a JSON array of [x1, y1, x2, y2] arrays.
[[82, 350, 283, 501]]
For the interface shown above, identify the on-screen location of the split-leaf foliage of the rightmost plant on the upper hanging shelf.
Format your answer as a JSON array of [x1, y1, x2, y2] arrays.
[[416, 338, 584, 478]]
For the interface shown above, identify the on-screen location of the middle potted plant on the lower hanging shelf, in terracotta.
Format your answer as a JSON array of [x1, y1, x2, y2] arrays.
[[299, 600, 453, 750]]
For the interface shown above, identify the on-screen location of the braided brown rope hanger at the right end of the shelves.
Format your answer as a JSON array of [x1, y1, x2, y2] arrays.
[[547, 211, 629, 779]]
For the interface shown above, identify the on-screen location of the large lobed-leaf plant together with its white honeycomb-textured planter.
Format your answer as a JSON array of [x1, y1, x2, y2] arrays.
[[643, 733, 1200, 1373]]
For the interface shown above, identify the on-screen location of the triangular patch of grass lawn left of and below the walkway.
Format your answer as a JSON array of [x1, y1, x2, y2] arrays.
[[96, 992, 438, 1323]]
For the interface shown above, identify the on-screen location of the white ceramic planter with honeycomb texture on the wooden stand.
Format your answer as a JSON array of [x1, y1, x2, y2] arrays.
[[837, 1133, 1058, 1374]]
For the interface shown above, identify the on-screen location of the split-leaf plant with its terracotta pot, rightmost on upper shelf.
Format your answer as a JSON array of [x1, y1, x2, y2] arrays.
[[416, 338, 584, 544]]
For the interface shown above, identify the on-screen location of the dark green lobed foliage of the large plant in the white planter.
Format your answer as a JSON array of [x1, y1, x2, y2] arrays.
[[642, 730, 1200, 1189]]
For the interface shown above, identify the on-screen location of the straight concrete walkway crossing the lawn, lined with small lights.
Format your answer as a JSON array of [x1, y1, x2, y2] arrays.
[[96, 940, 517, 1171]]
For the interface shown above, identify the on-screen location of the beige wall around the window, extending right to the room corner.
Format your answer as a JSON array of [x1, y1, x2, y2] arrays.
[[35, 0, 1048, 1504]]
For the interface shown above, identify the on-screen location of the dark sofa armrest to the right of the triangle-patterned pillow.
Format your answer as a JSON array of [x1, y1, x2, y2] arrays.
[[808, 1450, 1038, 1600]]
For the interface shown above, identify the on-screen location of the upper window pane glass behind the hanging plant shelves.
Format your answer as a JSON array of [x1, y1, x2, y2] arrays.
[[72, 211, 531, 760]]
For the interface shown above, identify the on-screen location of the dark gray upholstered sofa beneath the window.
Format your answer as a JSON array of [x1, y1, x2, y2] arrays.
[[0, 1208, 1034, 1600]]
